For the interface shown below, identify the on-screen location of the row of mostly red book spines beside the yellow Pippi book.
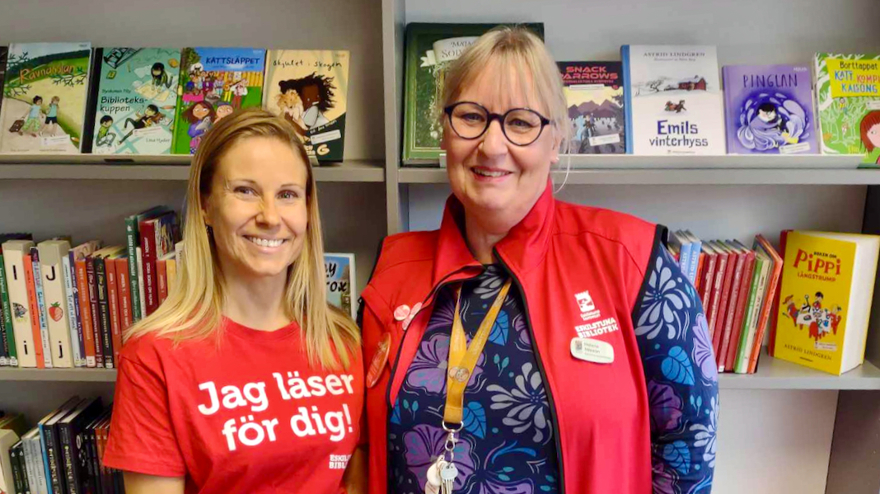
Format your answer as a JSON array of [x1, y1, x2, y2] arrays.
[[678, 235, 782, 374]]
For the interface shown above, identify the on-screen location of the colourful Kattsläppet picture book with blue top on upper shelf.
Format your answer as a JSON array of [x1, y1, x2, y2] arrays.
[[172, 48, 266, 154]]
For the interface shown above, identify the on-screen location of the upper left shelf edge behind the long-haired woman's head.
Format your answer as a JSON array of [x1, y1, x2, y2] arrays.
[[0, 154, 385, 182]]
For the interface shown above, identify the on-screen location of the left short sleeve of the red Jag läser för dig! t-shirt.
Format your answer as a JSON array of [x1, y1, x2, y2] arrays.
[[103, 350, 186, 477]]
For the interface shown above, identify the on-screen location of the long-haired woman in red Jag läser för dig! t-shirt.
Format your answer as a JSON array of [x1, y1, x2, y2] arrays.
[[104, 110, 364, 494]]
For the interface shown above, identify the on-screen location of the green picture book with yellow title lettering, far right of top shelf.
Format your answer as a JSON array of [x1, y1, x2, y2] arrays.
[[813, 53, 880, 166]]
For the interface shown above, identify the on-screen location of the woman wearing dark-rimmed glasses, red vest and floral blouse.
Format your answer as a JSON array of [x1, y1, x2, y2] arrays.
[[361, 28, 718, 494]]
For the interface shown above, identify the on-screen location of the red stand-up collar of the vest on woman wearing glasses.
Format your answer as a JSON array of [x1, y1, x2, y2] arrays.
[[432, 180, 556, 286]]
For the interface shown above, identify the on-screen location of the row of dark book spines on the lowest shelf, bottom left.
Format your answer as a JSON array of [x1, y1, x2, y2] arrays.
[[6, 404, 125, 494]]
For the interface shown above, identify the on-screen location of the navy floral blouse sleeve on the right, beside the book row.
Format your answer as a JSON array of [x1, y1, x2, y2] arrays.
[[633, 238, 719, 493]]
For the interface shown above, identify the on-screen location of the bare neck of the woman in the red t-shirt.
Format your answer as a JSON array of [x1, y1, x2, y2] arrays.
[[223, 270, 290, 331]]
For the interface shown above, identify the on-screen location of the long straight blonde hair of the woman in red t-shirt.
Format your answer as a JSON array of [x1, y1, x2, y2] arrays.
[[125, 108, 360, 369]]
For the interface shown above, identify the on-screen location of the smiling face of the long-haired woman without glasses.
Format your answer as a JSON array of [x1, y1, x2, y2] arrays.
[[203, 137, 308, 283]]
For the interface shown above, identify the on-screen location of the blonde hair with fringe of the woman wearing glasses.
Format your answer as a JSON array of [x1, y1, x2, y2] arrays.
[[436, 26, 571, 154]]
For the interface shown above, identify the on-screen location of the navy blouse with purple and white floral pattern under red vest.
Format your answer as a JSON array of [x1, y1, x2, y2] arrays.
[[388, 241, 718, 494]]
